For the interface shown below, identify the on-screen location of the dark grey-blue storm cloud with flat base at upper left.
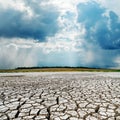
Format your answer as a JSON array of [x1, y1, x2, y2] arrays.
[[0, 1, 59, 41]]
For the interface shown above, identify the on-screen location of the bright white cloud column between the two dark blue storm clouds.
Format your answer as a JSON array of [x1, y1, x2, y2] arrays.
[[44, 0, 88, 51]]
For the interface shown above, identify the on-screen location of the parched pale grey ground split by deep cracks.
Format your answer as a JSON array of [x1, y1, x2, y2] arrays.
[[0, 72, 120, 120]]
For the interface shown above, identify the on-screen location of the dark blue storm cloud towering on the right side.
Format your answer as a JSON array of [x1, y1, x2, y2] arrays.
[[77, 2, 120, 49]]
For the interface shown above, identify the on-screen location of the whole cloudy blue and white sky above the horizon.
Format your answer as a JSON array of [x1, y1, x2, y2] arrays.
[[0, 0, 120, 69]]
